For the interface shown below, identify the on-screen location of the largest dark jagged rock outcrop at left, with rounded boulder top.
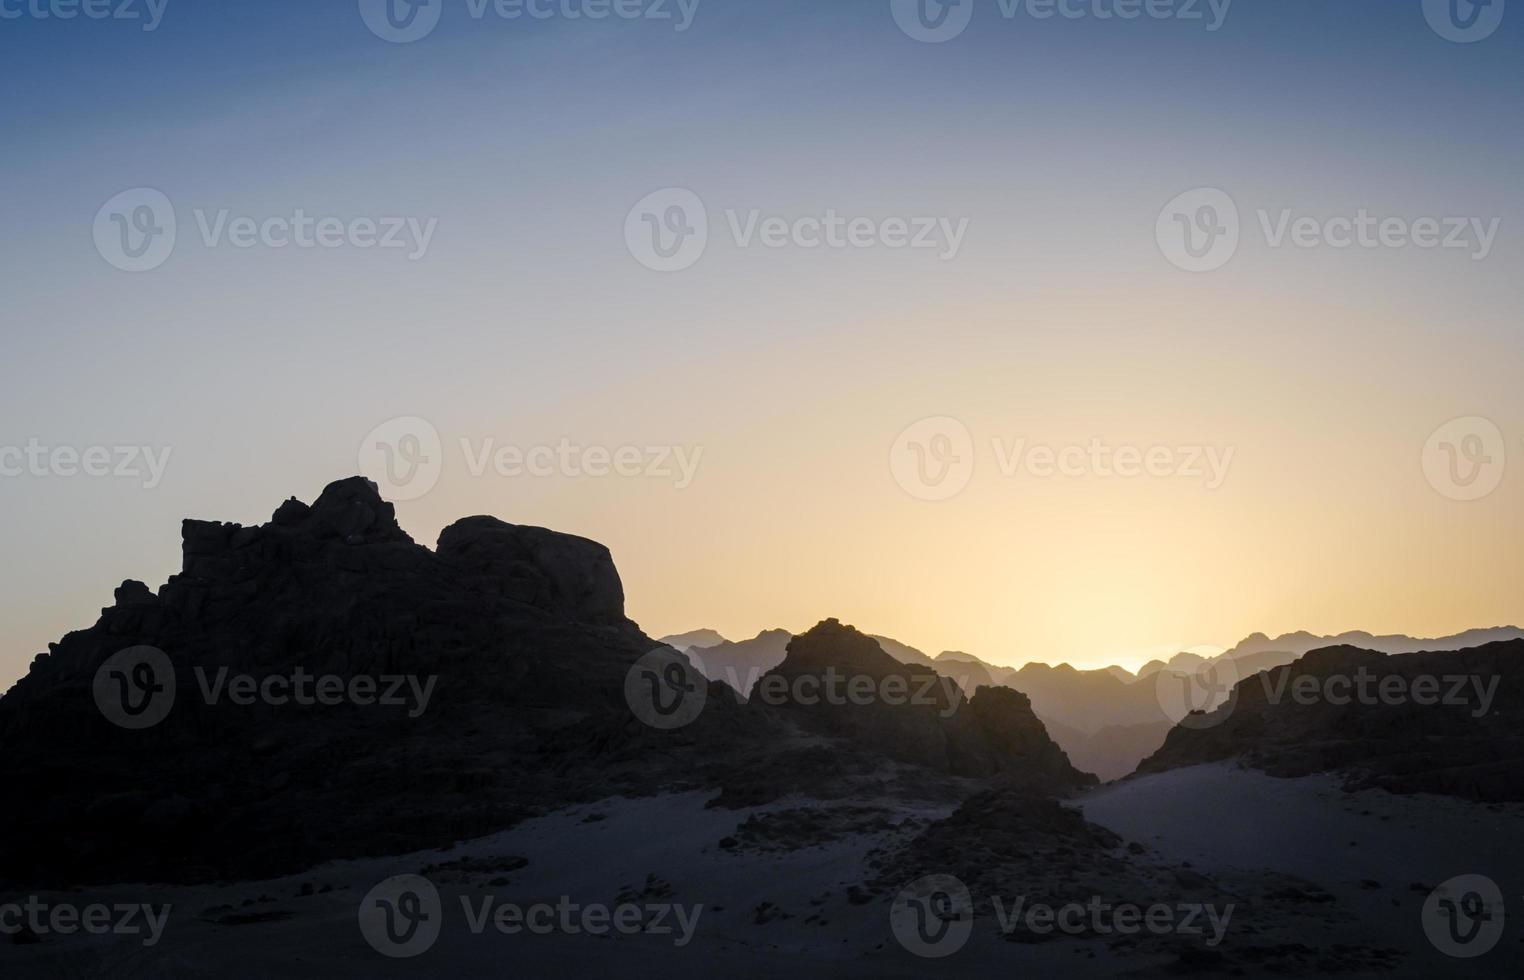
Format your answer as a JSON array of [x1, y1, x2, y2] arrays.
[[0, 479, 758, 884]]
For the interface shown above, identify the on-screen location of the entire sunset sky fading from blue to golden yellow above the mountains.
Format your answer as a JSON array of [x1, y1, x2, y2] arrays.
[[0, 0, 1524, 683]]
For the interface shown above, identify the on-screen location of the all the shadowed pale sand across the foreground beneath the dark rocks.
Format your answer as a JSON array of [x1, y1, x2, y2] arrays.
[[0, 767, 1524, 980]]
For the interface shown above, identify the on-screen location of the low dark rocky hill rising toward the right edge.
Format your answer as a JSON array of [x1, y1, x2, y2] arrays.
[[1138, 640, 1524, 800]]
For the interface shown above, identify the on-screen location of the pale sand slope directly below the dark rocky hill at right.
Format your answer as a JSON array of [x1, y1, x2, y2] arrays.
[[1081, 764, 1524, 977]]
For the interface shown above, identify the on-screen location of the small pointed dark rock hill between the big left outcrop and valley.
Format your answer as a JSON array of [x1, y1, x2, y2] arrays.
[[748, 619, 1096, 791]]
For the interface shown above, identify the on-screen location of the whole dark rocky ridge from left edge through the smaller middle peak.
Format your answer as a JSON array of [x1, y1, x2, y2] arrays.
[[0, 477, 1091, 887]]
